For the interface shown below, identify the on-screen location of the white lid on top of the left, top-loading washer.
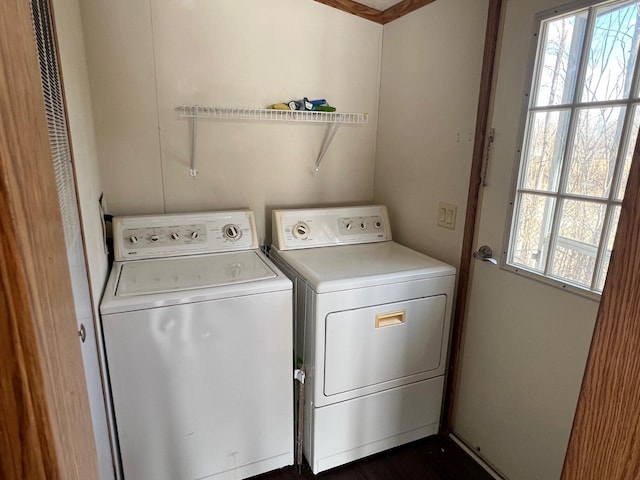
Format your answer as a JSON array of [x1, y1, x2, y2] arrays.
[[115, 251, 276, 296]]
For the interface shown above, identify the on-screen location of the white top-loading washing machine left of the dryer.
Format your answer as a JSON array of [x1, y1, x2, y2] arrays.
[[100, 210, 294, 480]]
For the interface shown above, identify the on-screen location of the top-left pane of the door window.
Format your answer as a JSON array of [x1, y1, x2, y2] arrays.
[[535, 10, 587, 107]]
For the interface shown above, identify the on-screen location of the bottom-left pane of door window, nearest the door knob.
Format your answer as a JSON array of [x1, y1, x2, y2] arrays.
[[510, 193, 555, 272]]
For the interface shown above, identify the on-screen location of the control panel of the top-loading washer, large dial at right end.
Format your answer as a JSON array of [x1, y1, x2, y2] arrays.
[[113, 210, 258, 261]]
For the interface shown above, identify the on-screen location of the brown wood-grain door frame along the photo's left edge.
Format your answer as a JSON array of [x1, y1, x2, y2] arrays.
[[0, 0, 99, 480]]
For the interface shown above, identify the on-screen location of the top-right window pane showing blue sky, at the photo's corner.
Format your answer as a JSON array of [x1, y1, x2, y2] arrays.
[[582, 1, 640, 102]]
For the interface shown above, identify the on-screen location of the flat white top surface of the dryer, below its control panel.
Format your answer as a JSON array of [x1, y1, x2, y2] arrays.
[[277, 241, 456, 293]]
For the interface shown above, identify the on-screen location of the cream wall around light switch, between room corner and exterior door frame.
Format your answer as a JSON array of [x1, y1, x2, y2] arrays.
[[374, 0, 488, 266]]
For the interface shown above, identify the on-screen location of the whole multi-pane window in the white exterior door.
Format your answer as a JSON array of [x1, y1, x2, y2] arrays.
[[507, 0, 640, 293]]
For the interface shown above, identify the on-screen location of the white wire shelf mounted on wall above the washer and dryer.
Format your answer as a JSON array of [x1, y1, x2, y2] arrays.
[[176, 105, 369, 125]]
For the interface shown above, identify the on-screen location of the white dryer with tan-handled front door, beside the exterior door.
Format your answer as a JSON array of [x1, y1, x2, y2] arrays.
[[270, 206, 455, 473]]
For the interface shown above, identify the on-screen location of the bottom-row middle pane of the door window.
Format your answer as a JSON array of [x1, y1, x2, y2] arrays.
[[551, 200, 606, 287]]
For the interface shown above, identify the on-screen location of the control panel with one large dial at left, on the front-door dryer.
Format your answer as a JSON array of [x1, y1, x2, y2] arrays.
[[272, 205, 391, 250]]
